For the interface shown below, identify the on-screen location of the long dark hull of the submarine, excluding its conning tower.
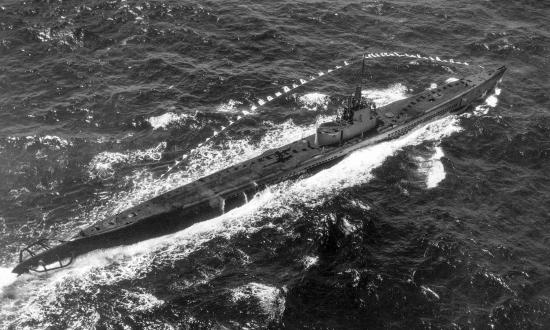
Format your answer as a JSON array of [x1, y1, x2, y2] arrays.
[[13, 67, 506, 274]]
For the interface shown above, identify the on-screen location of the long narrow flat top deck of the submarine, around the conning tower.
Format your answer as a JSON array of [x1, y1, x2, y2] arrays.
[[73, 68, 502, 239]]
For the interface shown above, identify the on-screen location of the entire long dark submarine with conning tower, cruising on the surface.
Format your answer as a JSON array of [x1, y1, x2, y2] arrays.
[[12, 57, 506, 274]]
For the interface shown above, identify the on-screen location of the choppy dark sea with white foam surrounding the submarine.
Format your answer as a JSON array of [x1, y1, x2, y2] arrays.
[[0, 0, 550, 329]]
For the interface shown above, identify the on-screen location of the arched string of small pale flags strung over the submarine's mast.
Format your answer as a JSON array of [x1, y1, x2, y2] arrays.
[[159, 52, 474, 179]]
